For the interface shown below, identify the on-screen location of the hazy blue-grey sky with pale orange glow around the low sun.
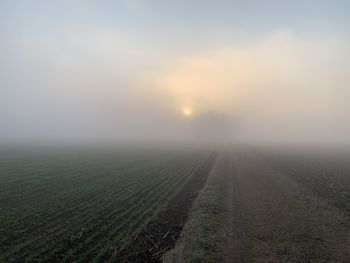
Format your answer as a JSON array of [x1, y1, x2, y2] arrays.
[[0, 0, 350, 143]]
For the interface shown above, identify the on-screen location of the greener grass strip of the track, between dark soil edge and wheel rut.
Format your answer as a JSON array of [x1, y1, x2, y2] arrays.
[[164, 156, 232, 263]]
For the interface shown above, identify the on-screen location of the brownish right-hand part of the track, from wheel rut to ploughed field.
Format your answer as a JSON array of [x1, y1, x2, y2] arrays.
[[234, 153, 350, 262]]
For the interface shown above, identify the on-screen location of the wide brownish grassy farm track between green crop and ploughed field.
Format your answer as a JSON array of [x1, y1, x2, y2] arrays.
[[164, 152, 350, 262]]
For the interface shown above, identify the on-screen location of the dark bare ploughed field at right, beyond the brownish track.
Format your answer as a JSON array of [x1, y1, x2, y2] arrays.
[[262, 151, 350, 215]]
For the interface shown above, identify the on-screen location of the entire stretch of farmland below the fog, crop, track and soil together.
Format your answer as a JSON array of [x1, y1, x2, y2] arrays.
[[0, 147, 350, 263]]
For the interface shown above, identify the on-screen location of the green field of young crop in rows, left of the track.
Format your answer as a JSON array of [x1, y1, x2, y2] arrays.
[[0, 150, 208, 262]]
